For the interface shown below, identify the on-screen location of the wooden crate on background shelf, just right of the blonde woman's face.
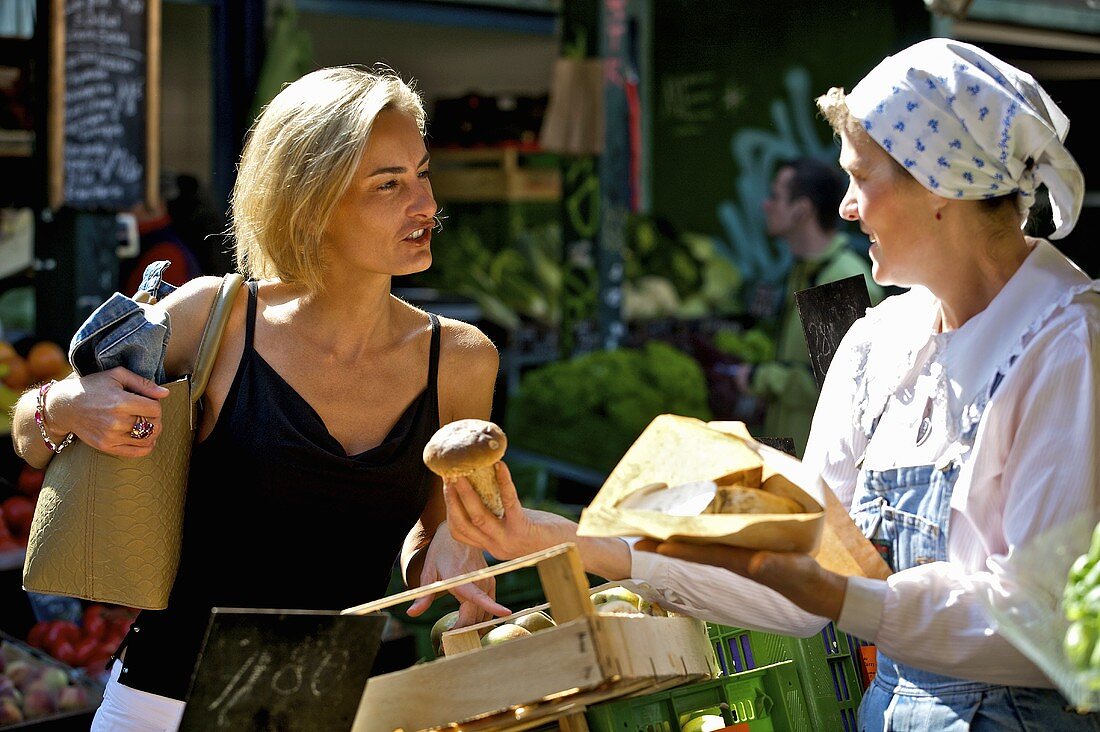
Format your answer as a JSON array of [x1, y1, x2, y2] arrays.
[[431, 148, 561, 204]]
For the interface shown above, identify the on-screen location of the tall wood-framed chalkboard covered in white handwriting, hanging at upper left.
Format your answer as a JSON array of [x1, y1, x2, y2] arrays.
[[48, 0, 161, 210]]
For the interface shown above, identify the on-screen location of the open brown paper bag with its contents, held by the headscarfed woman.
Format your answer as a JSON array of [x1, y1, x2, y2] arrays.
[[578, 414, 889, 578]]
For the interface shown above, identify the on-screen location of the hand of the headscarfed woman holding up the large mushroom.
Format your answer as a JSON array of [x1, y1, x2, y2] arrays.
[[443, 462, 576, 559]]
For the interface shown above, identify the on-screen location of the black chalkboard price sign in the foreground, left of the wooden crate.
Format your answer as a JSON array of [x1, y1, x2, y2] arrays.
[[179, 608, 386, 732]]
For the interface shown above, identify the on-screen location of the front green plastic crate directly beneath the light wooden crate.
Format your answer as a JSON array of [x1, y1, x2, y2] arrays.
[[585, 660, 811, 732]]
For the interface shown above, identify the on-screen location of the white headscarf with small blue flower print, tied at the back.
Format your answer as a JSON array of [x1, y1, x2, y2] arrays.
[[847, 39, 1085, 239]]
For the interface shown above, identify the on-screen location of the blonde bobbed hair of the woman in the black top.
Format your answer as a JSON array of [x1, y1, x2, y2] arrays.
[[232, 66, 425, 293]]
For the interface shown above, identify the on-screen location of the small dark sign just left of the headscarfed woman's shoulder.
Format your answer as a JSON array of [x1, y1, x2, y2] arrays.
[[794, 274, 871, 389]]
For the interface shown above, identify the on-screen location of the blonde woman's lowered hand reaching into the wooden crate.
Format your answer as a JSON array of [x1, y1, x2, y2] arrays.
[[406, 522, 512, 627]]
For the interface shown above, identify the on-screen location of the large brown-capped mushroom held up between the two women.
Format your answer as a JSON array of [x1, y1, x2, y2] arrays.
[[424, 419, 508, 516]]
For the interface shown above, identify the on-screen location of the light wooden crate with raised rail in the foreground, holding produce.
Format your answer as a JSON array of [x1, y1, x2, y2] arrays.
[[345, 544, 718, 732]]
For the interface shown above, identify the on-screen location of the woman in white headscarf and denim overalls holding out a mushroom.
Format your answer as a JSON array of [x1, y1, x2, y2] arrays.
[[444, 39, 1100, 730]]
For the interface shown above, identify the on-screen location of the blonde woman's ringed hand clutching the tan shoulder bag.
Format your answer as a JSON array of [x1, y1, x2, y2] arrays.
[[46, 367, 168, 458]]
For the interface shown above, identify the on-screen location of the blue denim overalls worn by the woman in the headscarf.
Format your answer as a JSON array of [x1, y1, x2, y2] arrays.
[[851, 374, 1100, 732]]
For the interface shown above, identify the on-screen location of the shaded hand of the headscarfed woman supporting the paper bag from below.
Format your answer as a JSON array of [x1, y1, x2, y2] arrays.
[[635, 539, 848, 620]]
